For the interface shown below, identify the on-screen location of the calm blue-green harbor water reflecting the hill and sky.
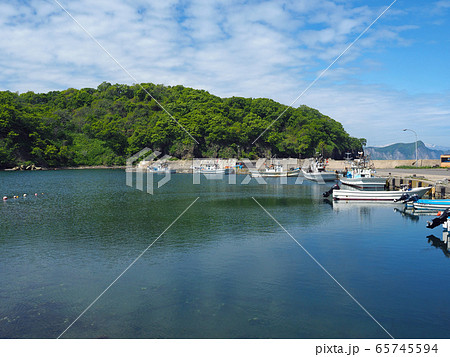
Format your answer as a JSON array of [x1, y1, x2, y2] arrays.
[[0, 170, 450, 338]]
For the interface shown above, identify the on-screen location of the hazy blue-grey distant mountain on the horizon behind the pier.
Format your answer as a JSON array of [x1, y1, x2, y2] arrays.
[[364, 141, 450, 160]]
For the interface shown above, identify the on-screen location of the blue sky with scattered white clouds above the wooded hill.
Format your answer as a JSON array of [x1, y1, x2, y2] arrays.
[[0, 0, 450, 146]]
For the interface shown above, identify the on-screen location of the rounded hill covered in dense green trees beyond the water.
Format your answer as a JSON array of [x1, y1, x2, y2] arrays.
[[0, 82, 364, 168]]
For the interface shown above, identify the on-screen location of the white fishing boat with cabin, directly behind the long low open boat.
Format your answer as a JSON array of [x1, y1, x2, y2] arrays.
[[339, 152, 388, 190]]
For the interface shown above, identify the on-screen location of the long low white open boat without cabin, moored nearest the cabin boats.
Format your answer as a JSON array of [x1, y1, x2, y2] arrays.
[[333, 186, 431, 203]]
